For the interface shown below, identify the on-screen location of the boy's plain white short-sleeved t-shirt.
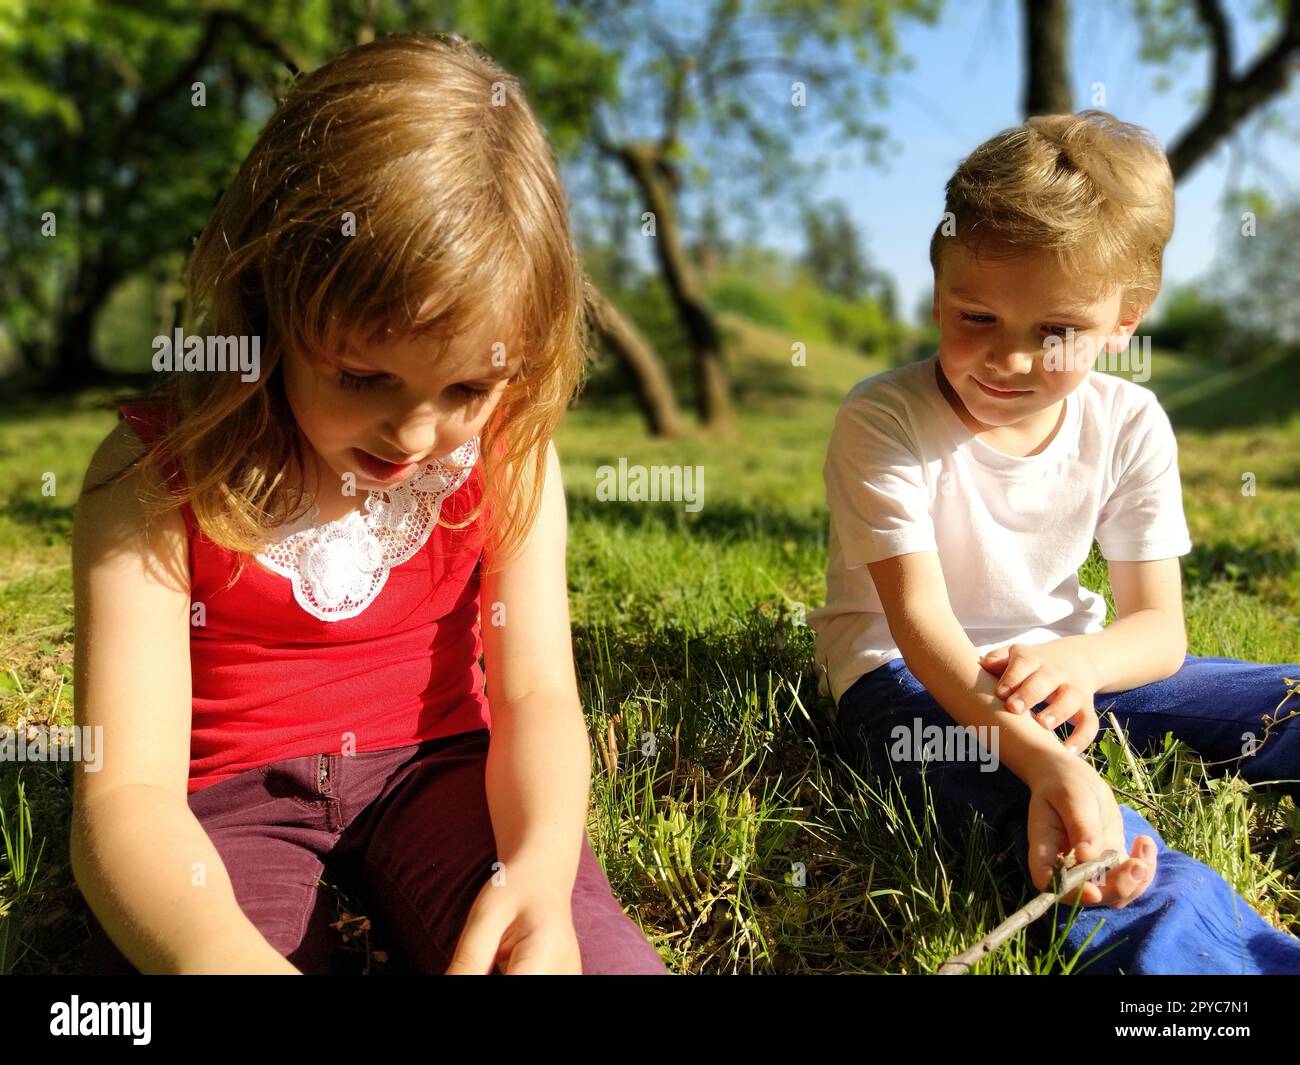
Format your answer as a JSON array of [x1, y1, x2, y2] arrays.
[[809, 352, 1192, 702]]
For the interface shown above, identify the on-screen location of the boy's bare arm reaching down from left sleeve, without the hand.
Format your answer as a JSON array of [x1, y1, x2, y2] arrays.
[[867, 551, 1092, 788]]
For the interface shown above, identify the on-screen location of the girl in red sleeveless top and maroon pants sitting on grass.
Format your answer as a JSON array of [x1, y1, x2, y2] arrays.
[[72, 35, 666, 973]]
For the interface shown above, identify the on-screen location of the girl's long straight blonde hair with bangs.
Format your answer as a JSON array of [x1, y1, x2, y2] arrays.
[[106, 34, 588, 579]]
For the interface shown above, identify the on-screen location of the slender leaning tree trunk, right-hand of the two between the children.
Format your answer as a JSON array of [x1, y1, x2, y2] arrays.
[[619, 144, 735, 432]]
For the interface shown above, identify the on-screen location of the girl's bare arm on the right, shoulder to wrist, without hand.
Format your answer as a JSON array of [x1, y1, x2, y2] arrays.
[[480, 443, 592, 902]]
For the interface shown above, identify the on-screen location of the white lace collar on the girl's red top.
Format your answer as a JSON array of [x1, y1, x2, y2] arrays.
[[256, 437, 478, 622]]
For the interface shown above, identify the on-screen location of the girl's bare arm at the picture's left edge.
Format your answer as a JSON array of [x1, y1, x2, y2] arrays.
[[69, 421, 296, 973]]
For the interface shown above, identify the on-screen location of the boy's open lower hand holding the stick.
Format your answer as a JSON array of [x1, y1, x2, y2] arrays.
[[1030, 758, 1156, 909]]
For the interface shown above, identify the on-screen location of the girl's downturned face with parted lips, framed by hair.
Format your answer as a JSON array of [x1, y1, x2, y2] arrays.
[[283, 322, 514, 490]]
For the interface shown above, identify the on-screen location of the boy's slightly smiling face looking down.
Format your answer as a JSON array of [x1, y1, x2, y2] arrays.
[[931, 241, 1140, 428]]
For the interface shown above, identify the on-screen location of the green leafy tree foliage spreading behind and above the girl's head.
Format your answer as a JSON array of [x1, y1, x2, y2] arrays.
[[0, 0, 616, 389]]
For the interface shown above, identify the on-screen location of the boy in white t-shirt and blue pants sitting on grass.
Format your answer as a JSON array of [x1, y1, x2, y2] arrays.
[[810, 112, 1300, 973]]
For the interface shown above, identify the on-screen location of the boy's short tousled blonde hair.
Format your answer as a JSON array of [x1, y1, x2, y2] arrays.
[[930, 111, 1174, 321]]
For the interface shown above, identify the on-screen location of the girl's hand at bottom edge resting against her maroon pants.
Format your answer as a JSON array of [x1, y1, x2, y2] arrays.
[[447, 863, 582, 977]]
